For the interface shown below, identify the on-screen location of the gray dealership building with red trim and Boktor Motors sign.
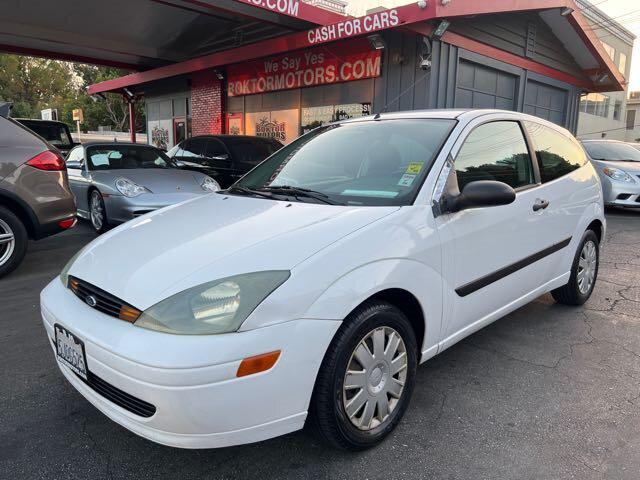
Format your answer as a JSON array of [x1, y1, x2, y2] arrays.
[[0, 0, 625, 148]]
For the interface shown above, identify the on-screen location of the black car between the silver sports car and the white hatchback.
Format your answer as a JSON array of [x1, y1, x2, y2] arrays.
[[167, 135, 282, 188]]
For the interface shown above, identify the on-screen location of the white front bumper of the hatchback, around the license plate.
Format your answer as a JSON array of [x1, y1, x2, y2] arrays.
[[41, 278, 340, 448]]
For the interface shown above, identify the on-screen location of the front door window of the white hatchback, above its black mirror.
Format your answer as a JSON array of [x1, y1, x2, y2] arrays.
[[455, 121, 535, 190]]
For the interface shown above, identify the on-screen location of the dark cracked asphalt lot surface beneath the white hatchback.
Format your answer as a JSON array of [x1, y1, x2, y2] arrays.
[[0, 210, 640, 480]]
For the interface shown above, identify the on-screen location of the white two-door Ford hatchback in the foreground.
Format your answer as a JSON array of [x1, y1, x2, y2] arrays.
[[42, 110, 605, 449]]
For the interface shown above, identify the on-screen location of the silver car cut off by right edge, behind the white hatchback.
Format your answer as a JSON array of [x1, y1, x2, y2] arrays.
[[582, 140, 640, 207]]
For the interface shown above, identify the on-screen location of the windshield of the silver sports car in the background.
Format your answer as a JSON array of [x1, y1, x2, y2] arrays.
[[87, 145, 174, 170]]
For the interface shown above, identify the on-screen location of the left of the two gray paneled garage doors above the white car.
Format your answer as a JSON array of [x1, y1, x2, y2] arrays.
[[455, 60, 516, 110]]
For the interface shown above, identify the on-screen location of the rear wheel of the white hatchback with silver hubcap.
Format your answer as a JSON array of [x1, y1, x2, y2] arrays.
[[551, 230, 600, 305]]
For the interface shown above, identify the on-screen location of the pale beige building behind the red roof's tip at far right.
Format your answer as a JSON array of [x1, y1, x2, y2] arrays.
[[578, 0, 635, 140]]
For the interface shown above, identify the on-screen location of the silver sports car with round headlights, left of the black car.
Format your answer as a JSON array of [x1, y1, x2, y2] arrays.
[[67, 143, 220, 233]]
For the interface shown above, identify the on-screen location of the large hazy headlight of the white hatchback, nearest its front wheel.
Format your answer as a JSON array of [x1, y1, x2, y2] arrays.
[[135, 270, 290, 335]]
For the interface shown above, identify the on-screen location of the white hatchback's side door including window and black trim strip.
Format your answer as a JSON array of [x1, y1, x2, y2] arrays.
[[436, 115, 554, 348]]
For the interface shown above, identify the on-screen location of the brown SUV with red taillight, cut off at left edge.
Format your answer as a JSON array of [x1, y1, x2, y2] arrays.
[[0, 108, 76, 277]]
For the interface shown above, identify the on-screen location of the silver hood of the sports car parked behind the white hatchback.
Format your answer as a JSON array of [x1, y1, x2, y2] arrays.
[[91, 168, 205, 193]]
